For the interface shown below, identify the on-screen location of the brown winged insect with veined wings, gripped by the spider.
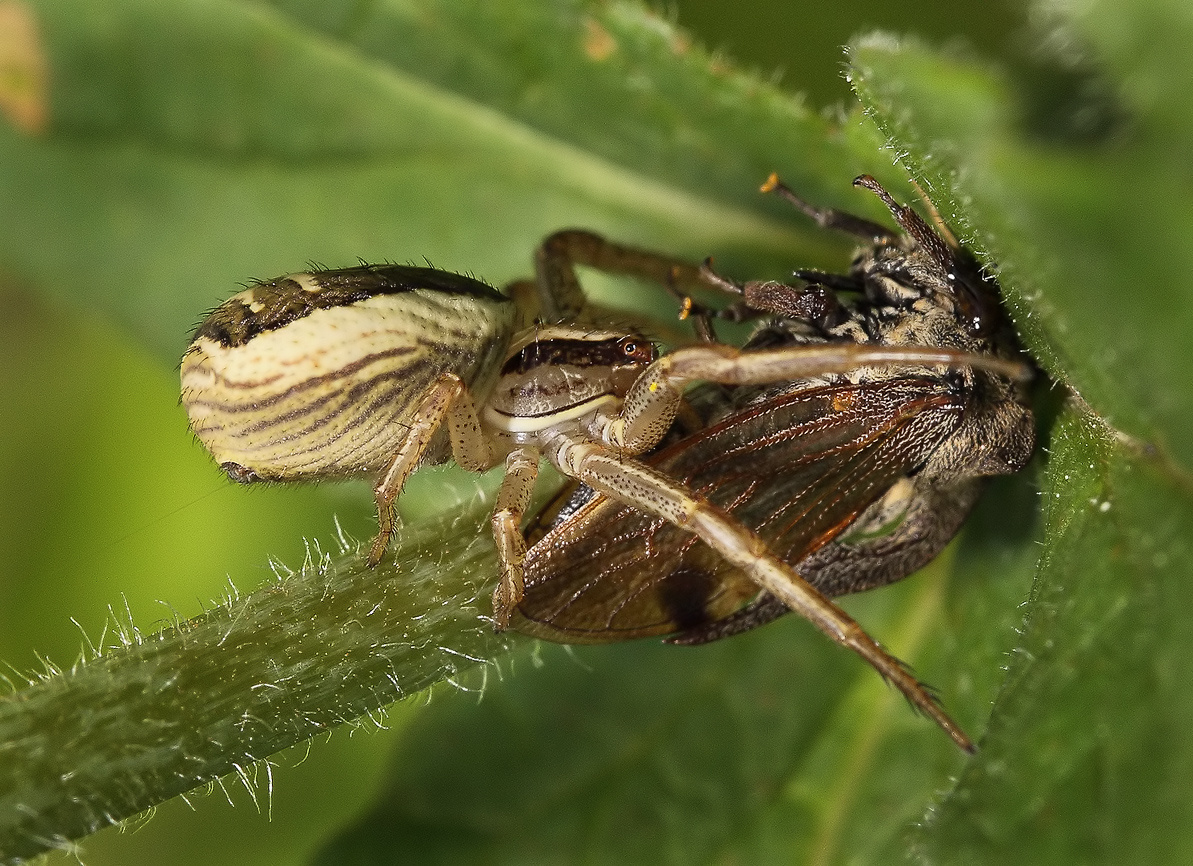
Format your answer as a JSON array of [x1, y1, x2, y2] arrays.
[[513, 175, 1034, 730]]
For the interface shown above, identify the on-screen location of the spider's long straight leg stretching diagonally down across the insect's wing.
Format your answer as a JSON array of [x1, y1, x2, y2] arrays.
[[544, 431, 973, 751]]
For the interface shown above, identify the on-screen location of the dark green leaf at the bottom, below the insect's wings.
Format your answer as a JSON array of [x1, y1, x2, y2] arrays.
[[316, 484, 1032, 864]]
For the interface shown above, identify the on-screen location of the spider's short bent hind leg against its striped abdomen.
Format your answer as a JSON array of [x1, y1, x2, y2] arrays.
[[369, 373, 493, 568]]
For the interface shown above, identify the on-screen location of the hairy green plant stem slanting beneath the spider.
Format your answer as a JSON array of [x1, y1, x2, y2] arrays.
[[0, 503, 511, 862]]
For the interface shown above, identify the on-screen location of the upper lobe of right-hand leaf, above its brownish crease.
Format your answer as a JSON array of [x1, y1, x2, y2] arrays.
[[851, 13, 1193, 466]]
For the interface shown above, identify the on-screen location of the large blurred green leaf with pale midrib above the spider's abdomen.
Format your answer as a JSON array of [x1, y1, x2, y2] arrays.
[[0, 0, 880, 359]]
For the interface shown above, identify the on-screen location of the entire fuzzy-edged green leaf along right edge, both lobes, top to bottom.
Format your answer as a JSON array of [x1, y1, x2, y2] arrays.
[[851, 2, 1193, 864]]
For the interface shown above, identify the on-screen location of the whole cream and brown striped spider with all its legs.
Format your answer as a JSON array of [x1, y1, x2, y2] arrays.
[[181, 176, 1026, 749]]
